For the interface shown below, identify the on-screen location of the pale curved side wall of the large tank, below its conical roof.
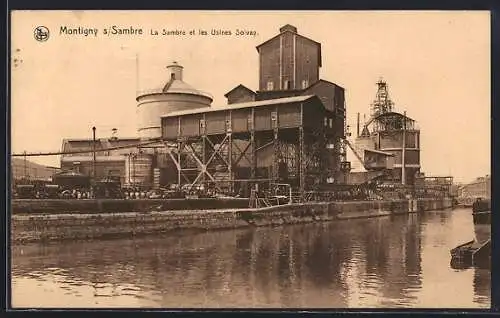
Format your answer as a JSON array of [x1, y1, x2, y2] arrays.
[[137, 93, 212, 138]]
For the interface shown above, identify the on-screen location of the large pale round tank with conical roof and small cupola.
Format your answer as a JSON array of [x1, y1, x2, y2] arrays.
[[136, 62, 213, 139]]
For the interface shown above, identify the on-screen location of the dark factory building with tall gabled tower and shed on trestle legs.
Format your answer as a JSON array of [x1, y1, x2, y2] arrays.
[[159, 25, 346, 192]]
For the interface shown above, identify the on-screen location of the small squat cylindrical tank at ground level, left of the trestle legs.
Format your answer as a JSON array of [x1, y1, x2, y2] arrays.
[[125, 154, 153, 187]]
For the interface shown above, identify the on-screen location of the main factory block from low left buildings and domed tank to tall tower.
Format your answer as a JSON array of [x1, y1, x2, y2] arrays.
[[61, 25, 346, 193]]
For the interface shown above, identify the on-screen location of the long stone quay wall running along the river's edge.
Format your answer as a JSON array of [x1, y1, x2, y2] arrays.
[[11, 199, 452, 243]]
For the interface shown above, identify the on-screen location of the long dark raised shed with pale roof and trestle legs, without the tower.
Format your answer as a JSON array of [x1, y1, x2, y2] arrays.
[[162, 95, 344, 192]]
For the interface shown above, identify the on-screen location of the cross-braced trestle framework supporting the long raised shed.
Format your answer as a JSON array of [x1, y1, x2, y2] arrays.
[[166, 126, 340, 194]]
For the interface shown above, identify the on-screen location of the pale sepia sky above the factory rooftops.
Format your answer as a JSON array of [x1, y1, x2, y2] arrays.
[[11, 11, 491, 182]]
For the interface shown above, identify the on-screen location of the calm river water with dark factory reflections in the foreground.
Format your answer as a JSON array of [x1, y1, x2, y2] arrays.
[[12, 209, 491, 308]]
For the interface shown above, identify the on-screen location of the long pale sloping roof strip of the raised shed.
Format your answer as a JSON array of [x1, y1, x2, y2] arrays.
[[162, 95, 317, 117]]
